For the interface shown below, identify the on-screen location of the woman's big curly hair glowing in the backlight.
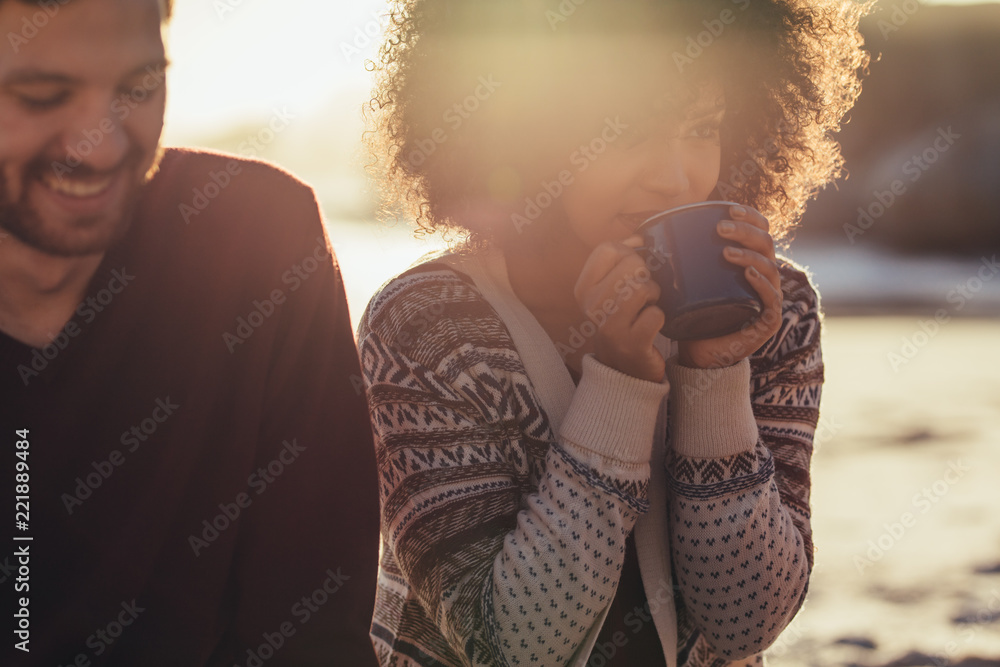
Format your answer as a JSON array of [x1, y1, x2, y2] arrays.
[[365, 0, 871, 247]]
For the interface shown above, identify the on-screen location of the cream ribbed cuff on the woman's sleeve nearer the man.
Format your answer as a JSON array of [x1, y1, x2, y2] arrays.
[[561, 355, 670, 463]]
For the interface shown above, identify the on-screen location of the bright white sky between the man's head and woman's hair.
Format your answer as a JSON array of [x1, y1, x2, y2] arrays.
[[166, 0, 992, 143]]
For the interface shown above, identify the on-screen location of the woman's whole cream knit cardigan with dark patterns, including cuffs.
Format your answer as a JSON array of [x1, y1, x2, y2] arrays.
[[359, 248, 822, 666]]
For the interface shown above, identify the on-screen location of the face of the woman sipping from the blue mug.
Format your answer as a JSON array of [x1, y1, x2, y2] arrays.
[[561, 85, 725, 247]]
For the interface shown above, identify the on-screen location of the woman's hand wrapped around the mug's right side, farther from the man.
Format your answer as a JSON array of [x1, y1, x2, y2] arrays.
[[677, 206, 783, 368]]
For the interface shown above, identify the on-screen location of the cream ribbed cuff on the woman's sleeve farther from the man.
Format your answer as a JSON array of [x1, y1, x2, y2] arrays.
[[667, 356, 757, 458]]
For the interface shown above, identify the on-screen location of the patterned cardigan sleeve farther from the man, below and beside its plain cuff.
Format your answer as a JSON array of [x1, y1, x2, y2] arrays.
[[667, 258, 823, 667]]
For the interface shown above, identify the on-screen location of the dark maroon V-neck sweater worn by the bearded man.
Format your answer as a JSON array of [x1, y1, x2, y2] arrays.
[[0, 150, 378, 667]]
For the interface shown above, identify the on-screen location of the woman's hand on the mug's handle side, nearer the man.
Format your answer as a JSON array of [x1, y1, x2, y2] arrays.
[[574, 236, 666, 382]]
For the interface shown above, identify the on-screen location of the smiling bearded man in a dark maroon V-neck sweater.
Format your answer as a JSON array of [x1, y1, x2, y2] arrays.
[[0, 0, 378, 667]]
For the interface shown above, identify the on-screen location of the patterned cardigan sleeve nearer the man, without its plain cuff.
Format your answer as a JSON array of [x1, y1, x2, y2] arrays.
[[359, 264, 649, 666]]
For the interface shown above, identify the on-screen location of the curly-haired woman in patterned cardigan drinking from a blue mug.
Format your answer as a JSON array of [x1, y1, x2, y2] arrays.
[[359, 0, 866, 667]]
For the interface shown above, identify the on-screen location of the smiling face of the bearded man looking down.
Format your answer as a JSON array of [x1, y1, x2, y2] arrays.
[[0, 0, 166, 257]]
